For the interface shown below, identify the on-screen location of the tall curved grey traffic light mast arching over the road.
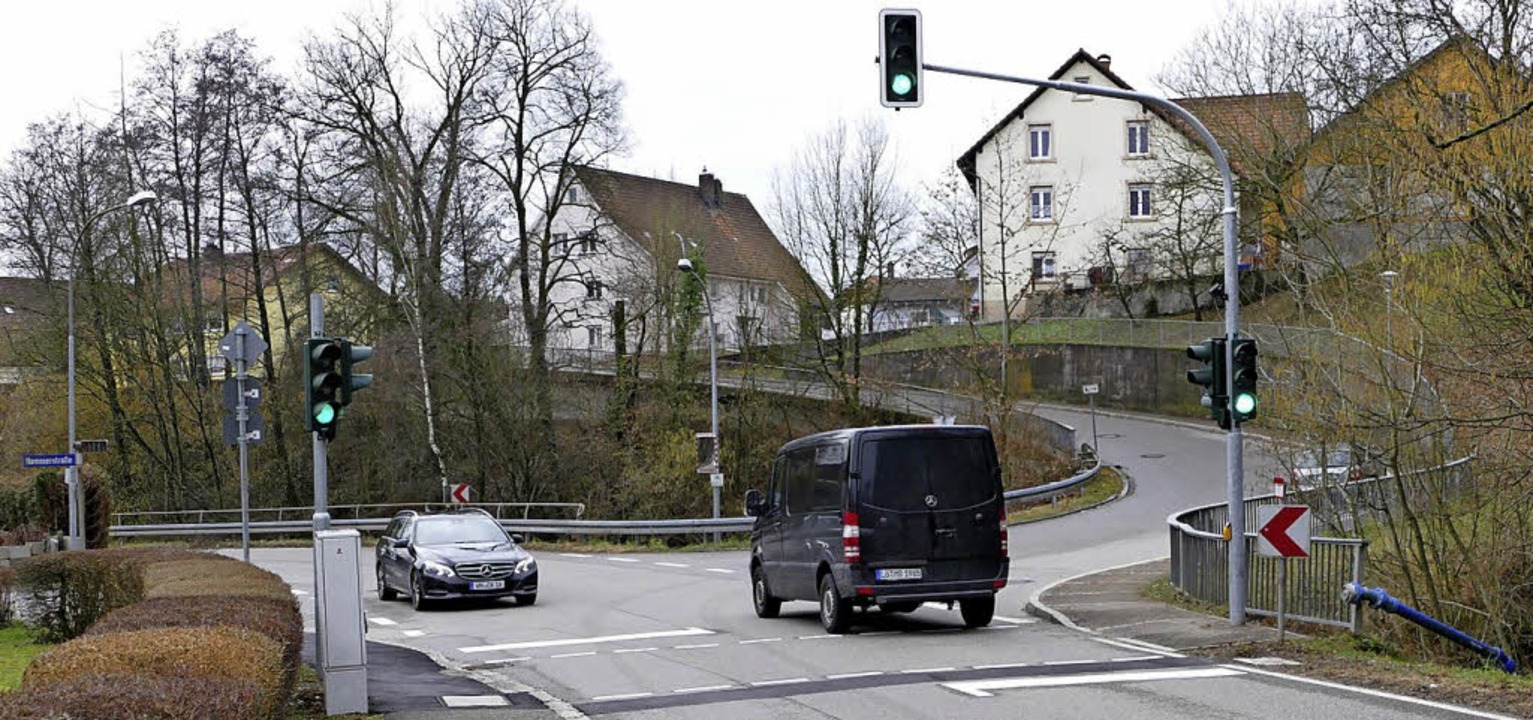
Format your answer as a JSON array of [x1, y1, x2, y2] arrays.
[[921, 63, 1246, 625]]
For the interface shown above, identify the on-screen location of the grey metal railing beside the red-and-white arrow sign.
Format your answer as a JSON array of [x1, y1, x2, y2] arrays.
[[1167, 457, 1473, 633]]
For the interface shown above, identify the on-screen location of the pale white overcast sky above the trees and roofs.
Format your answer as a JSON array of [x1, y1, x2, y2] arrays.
[[0, 0, 1229, 213]]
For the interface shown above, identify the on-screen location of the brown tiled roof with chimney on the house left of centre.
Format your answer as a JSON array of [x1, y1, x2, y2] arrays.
[[575, 165, 819, 299]]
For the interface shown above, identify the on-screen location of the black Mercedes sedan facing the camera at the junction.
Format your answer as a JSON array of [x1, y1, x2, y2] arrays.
[[377, 509, 538, 610]]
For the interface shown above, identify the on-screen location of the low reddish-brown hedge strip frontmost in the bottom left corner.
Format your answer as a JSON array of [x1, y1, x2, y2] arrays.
[[0, 674, 262, 720]]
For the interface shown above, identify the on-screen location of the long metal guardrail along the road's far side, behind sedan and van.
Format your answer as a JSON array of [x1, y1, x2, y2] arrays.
[[107, 463, 1102, 538]]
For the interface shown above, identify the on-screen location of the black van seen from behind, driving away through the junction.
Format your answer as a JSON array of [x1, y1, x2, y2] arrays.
[[745, 424, 1009, 633]]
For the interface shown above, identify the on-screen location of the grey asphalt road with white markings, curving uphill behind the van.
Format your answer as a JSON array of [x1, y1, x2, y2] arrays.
[[253, 409, 1502, 720]]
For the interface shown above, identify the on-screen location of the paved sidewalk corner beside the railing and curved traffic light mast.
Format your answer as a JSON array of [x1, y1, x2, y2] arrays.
[[1027, 559, 1292, 651]]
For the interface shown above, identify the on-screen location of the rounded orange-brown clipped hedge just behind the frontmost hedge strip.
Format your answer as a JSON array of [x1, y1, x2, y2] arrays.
[[21, 627, 288, 718]]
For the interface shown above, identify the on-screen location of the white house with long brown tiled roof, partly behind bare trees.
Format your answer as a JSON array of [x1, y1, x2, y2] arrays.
[[549, 165, 819, 352]]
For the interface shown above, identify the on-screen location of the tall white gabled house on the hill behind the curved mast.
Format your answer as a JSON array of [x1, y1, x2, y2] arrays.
[[958, 51, 1308, 320]]
